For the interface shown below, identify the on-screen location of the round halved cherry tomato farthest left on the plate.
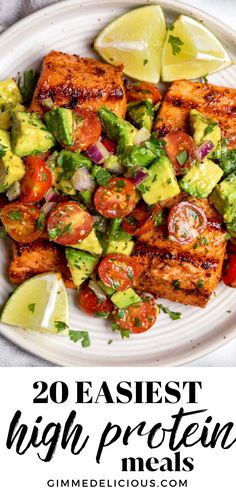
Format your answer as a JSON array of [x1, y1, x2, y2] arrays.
[[0, 202, 44, 244]]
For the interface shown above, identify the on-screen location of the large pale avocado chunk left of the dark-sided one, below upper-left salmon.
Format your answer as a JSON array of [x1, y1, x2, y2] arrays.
[[12, 112, 55, 158]]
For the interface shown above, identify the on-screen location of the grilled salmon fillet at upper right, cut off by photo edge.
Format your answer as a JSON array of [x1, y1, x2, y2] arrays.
[[154, 80, 236, 148]]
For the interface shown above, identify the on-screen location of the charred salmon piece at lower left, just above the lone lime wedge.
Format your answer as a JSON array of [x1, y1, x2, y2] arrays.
[[9, 239, 75, 288]]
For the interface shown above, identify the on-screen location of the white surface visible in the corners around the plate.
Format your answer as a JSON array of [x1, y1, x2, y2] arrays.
[[0, 0, 236, 367]]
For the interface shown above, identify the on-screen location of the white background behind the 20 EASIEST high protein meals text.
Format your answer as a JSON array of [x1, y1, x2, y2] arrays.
[[0, 368, 236, 495]]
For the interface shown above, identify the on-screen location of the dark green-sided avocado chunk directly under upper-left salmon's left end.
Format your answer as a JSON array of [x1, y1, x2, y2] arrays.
[[44, 108, 74, 146]]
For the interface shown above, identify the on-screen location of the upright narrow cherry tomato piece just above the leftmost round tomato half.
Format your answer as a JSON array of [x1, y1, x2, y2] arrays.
[[21, 156, 52, 203]]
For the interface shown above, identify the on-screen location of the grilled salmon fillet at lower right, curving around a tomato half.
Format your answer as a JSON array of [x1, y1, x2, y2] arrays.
[[133, 197, 227, 307]]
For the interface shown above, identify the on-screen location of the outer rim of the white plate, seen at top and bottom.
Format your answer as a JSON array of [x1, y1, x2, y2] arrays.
[[0, 0, 236, 367]]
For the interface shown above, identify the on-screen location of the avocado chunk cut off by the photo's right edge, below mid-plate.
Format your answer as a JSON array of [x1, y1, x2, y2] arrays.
[[209, 172, 236, 223]]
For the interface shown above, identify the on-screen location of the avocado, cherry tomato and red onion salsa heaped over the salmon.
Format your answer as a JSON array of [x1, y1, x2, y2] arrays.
[[0, 67, 233, 344]]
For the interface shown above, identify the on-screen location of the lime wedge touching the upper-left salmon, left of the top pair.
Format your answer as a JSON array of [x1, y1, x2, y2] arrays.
[[94, 5, 166, 83]]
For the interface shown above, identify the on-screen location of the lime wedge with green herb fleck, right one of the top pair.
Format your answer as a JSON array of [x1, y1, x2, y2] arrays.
[[162, 15, 232, 81]]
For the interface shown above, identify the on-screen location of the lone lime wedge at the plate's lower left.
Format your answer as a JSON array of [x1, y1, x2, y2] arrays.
[[1, 273, 69, 335]]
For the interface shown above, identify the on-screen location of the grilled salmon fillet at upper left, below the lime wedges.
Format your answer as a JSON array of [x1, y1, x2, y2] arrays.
[[30, 51, 126, 117]]
